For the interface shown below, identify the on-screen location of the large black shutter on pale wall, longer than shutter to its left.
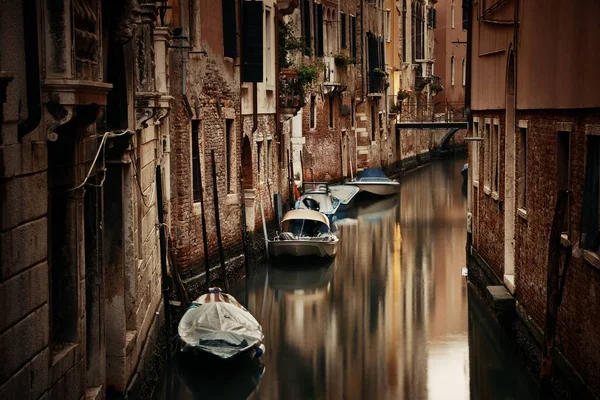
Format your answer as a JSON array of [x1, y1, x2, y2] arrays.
[[242, 1, 263, 82]]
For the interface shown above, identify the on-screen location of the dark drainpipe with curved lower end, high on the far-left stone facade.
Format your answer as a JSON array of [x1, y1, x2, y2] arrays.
[[17, 0, 42, 142]]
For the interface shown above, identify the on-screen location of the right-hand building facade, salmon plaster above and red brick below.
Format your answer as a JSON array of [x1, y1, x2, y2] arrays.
[[469, 0, 600, 396]]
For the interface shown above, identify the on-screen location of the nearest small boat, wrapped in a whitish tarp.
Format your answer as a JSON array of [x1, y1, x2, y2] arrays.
[[178, 287, 264, 360]]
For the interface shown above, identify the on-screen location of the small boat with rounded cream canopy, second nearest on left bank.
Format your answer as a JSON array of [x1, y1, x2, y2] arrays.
[[269, 209, 339, 257]]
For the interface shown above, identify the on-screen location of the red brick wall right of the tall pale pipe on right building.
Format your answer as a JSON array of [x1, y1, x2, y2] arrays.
[[515, 111, 600, 393]]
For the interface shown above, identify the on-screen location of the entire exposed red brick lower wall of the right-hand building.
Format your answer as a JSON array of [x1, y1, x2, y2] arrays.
[[469, 110, 600, 393]]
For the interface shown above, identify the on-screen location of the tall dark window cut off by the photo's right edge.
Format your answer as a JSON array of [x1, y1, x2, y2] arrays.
[[581, 135, 600, 251]]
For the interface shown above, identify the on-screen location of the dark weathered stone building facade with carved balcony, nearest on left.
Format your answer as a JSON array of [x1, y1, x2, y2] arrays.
[[0, 0, 170, 399]]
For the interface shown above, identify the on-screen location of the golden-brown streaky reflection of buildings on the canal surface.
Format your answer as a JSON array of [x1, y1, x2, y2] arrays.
[[241, 160, 469, 399]]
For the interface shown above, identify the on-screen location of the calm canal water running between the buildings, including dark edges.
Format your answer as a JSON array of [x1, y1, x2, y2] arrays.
[[154, 157, 536, 400]]
